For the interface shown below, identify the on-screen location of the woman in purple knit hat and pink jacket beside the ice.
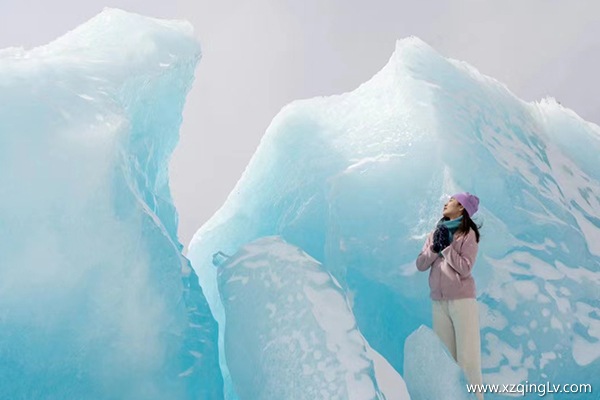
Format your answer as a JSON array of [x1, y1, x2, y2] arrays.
[[417, 192, 483, 399]]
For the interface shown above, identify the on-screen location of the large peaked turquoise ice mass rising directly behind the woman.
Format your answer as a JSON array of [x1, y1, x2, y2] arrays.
[[188, 38, 600, 398]]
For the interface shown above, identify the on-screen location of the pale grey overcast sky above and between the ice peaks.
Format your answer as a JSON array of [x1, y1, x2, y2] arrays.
[[0, 0, 600, 246]]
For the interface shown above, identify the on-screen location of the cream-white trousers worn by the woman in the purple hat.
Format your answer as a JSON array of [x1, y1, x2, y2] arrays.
[[433, 298, 483, 399]]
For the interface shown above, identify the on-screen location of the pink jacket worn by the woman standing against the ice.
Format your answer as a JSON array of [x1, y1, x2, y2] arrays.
[[417, 229, 479, 300]]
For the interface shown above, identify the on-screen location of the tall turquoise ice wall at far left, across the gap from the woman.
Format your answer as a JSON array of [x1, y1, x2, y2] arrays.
[[0, 9, 223, 399]]
